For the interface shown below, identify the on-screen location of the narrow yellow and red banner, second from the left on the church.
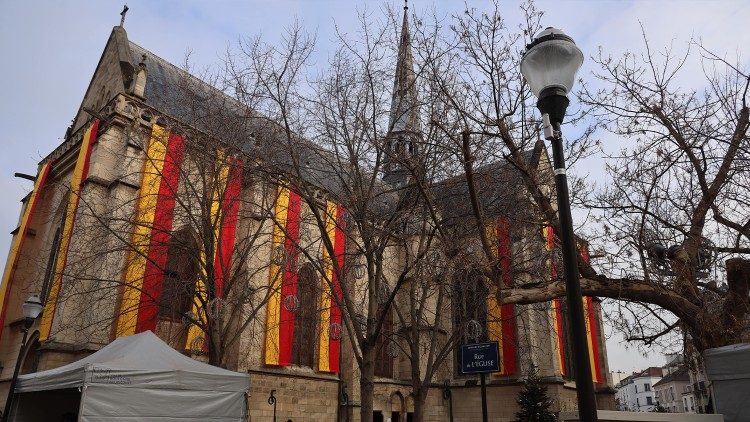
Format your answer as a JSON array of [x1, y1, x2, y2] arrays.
[[39, 120, 99, 341]]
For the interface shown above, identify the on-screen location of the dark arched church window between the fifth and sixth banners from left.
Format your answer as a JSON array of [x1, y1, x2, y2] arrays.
[[292, 264, 319, 368]]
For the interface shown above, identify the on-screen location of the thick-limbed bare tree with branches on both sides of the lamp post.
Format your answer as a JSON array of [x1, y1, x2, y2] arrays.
[[424, 0, 750, 351]]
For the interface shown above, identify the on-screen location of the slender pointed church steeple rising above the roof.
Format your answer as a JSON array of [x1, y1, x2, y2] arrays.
[[383, 4, 422, 186]]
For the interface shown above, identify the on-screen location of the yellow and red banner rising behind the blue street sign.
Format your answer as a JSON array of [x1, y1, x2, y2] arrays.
[[486, 218, 517, 375]]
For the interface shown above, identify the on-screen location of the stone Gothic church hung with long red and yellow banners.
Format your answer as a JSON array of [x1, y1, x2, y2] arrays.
[[0, 6, 614, 422]]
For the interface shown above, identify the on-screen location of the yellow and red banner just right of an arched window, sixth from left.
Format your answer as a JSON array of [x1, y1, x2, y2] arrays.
[[318, 201, 346, 373]]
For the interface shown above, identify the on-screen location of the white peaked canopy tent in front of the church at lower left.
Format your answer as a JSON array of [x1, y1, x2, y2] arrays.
[[13, 331, 250, 422]]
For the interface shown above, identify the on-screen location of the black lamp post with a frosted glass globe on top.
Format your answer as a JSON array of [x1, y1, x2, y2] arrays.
[[521, 28, 597, 422]]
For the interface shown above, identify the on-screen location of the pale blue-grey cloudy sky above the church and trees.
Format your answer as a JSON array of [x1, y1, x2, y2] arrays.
[[0, 0, 750, 371]]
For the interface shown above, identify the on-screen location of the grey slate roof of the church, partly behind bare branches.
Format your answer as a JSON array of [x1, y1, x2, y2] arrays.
[[64, 27, 543, 224]]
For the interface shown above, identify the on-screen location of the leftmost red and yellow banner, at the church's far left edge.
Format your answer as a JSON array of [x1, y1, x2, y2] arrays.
[[0, 161, 52, 337]]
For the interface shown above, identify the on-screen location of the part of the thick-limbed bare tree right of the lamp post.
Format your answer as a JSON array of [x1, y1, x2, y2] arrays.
[[581, 32, 750, 351]]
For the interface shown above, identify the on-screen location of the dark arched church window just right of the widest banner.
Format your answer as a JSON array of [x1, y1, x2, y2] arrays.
[[159, 227, 200, 321]]
